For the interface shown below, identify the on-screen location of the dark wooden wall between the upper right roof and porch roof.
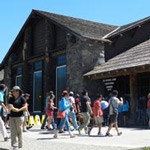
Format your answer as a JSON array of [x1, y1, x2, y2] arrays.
[[105, 21, 150, 61]]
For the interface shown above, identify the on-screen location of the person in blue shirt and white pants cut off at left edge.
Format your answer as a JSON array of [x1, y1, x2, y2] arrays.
[[0, 84, 8, 141]]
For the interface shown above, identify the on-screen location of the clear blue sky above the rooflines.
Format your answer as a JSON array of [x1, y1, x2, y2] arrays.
[[0, 0, 150, 62]]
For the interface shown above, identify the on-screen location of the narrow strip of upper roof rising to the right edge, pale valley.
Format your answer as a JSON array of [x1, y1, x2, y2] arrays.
[[103, 17, 150, 39]]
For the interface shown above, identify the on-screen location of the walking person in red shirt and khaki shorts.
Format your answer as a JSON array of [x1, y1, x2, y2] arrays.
[[88, 94, 104, 137]]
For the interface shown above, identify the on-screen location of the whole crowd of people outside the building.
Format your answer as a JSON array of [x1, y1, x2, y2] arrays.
[[0, 84, 150, 149]]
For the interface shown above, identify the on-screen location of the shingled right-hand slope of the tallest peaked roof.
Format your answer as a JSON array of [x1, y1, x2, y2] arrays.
[[33, 10, 117, 40]]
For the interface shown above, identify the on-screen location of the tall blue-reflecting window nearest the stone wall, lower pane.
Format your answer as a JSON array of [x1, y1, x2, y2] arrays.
[[56, 65, 66, 104]]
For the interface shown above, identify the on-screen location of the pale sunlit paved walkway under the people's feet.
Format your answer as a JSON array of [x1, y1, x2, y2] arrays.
[[0, 127, 150, 150]]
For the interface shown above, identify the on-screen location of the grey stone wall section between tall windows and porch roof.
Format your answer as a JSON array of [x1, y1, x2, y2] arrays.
[[66, 38, 104, 98]]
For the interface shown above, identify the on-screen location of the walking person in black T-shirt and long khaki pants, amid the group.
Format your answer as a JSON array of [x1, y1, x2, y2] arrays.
[[78, 90, 93, 135]]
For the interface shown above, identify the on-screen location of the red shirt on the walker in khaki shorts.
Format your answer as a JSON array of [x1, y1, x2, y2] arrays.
[[93, 100, 103, 117]]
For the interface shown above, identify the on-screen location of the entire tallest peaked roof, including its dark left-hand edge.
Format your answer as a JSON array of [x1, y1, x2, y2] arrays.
[[2, 10, 117, 65]]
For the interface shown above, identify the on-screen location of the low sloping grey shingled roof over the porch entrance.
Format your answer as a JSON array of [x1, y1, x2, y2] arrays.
[[85, 40, 150, 76]]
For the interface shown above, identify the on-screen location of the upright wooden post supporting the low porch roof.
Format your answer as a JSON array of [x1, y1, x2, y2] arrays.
[[130, 74, 137, 124]]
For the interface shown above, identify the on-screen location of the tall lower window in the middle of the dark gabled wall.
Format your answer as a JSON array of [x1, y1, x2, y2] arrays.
[[33, 71, 42, 112]]
